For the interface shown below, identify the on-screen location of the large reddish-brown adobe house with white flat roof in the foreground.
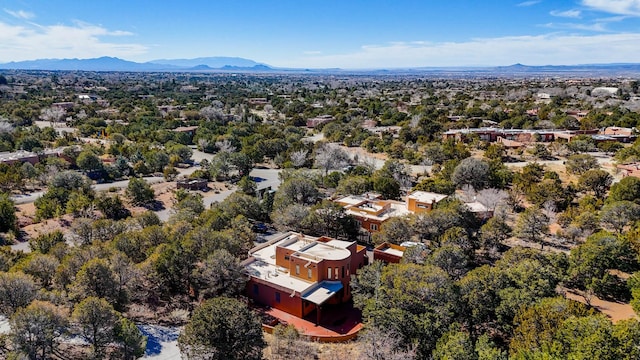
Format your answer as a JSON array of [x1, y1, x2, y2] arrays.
[[242, 232, 366, 324]]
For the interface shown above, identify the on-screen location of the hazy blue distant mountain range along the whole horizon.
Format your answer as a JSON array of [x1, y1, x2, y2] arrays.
[[0, 56, 640, 76]]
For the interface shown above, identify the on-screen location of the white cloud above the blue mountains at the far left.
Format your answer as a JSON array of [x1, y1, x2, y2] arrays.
[[0, 21, 147, 62]]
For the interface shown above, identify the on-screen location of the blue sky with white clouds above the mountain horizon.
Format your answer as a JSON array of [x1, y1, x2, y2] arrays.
[[0, 0, 640, 69]]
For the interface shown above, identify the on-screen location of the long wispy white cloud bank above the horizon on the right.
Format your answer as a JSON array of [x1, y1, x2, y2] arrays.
[[290, 33, 640, 69]]
